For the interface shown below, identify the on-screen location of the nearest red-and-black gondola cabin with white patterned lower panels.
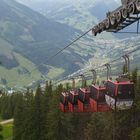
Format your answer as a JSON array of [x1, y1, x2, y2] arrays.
[[105, 80, 134, 110]]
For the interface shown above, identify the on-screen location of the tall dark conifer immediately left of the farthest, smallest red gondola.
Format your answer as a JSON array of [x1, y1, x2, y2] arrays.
[[47, 85, 64, 140]]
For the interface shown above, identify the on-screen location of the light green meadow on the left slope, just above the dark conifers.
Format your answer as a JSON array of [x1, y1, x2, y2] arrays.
[[0, 53, 40, 86]]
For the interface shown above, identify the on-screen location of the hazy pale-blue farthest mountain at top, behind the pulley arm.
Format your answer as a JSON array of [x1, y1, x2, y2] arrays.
[[18, 0, 136, 39]]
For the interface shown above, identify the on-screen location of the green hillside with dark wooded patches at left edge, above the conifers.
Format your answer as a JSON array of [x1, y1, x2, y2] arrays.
[[0, 38, 41, 89]]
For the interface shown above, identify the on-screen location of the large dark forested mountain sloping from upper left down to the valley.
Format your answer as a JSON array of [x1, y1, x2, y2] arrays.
[[0, 0, 100, 88]]
